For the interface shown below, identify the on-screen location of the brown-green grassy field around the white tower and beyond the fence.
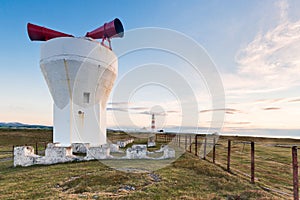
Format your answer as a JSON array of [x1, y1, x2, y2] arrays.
[[0, 130, 299, 199]]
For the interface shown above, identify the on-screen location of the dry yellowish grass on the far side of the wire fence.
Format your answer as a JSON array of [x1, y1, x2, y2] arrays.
[[208, 138, 300, 198]]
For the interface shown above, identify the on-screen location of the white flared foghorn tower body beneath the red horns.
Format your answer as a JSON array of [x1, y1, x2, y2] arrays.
[[27, 19, 123, 146]]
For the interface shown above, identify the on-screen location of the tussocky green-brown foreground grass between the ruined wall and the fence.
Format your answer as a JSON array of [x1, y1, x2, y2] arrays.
[[0, 154, 273, 199]]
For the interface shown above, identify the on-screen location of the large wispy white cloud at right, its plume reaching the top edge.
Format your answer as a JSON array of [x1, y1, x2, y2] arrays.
[[223, 1, 300, 98]]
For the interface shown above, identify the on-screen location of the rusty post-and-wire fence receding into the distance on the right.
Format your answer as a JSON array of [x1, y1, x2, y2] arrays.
[[156, 134, 300, 200]]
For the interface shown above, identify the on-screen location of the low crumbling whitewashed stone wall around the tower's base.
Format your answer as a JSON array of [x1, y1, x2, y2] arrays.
[[14, 143, 175, 167]]
